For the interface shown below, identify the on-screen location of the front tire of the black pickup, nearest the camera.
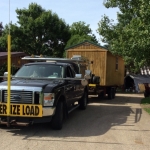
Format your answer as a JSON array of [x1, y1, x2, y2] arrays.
[[51, 101, 64, 130]]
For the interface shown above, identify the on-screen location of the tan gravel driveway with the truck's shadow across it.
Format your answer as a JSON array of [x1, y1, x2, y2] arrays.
[[0, 94, 150, 150]]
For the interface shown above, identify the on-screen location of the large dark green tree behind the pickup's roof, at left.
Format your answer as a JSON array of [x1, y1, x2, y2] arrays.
[[0, 3, 70, 57]]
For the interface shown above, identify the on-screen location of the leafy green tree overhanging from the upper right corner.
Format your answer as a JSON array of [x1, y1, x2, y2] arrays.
[[98, 0, 150, 72]]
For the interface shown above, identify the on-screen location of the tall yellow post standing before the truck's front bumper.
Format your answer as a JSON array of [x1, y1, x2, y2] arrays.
[[7, 34, 11, 116]]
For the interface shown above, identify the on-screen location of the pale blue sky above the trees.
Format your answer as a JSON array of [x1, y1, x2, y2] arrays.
[[0, 0, 118, 44]]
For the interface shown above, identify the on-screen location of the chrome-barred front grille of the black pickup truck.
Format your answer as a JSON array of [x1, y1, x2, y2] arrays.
[[2, 90, 34, 104]]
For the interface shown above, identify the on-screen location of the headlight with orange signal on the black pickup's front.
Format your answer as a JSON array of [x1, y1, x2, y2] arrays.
[[44, 93, 55, 106]]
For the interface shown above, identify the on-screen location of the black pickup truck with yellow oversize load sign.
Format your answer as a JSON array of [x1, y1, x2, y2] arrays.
[[0, 58, 88, 130]]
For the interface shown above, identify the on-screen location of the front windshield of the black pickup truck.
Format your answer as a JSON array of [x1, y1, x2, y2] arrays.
[[15, 64, 63, 78]]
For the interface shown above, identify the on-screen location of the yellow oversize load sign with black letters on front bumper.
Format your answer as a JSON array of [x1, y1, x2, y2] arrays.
[[0, 103, 42, 117]]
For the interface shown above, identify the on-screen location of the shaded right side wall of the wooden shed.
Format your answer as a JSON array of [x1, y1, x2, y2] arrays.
[[106, 52, 125, 85]]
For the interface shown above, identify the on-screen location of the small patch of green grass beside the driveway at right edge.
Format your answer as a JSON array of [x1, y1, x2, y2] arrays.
[[141, 97, 150, 115]]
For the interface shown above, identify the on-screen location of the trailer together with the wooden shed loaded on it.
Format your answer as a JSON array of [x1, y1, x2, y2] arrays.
[[65, 41, 125, 99]]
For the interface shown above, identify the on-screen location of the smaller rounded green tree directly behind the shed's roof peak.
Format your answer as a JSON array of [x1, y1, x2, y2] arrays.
[[65, 21, 98, 48]]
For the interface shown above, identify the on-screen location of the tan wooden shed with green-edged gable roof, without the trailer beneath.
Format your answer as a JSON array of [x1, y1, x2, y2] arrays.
[[66, 41, 125, 86]]
